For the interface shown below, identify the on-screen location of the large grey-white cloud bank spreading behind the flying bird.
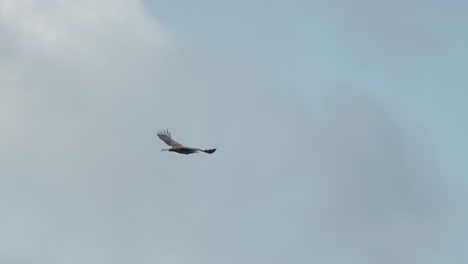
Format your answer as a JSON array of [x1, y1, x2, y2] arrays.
[[0, 0, 461, 264]]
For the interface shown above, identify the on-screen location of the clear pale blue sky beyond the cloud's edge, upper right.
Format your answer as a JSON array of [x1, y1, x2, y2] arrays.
[[147, 0, 468, 187]]
